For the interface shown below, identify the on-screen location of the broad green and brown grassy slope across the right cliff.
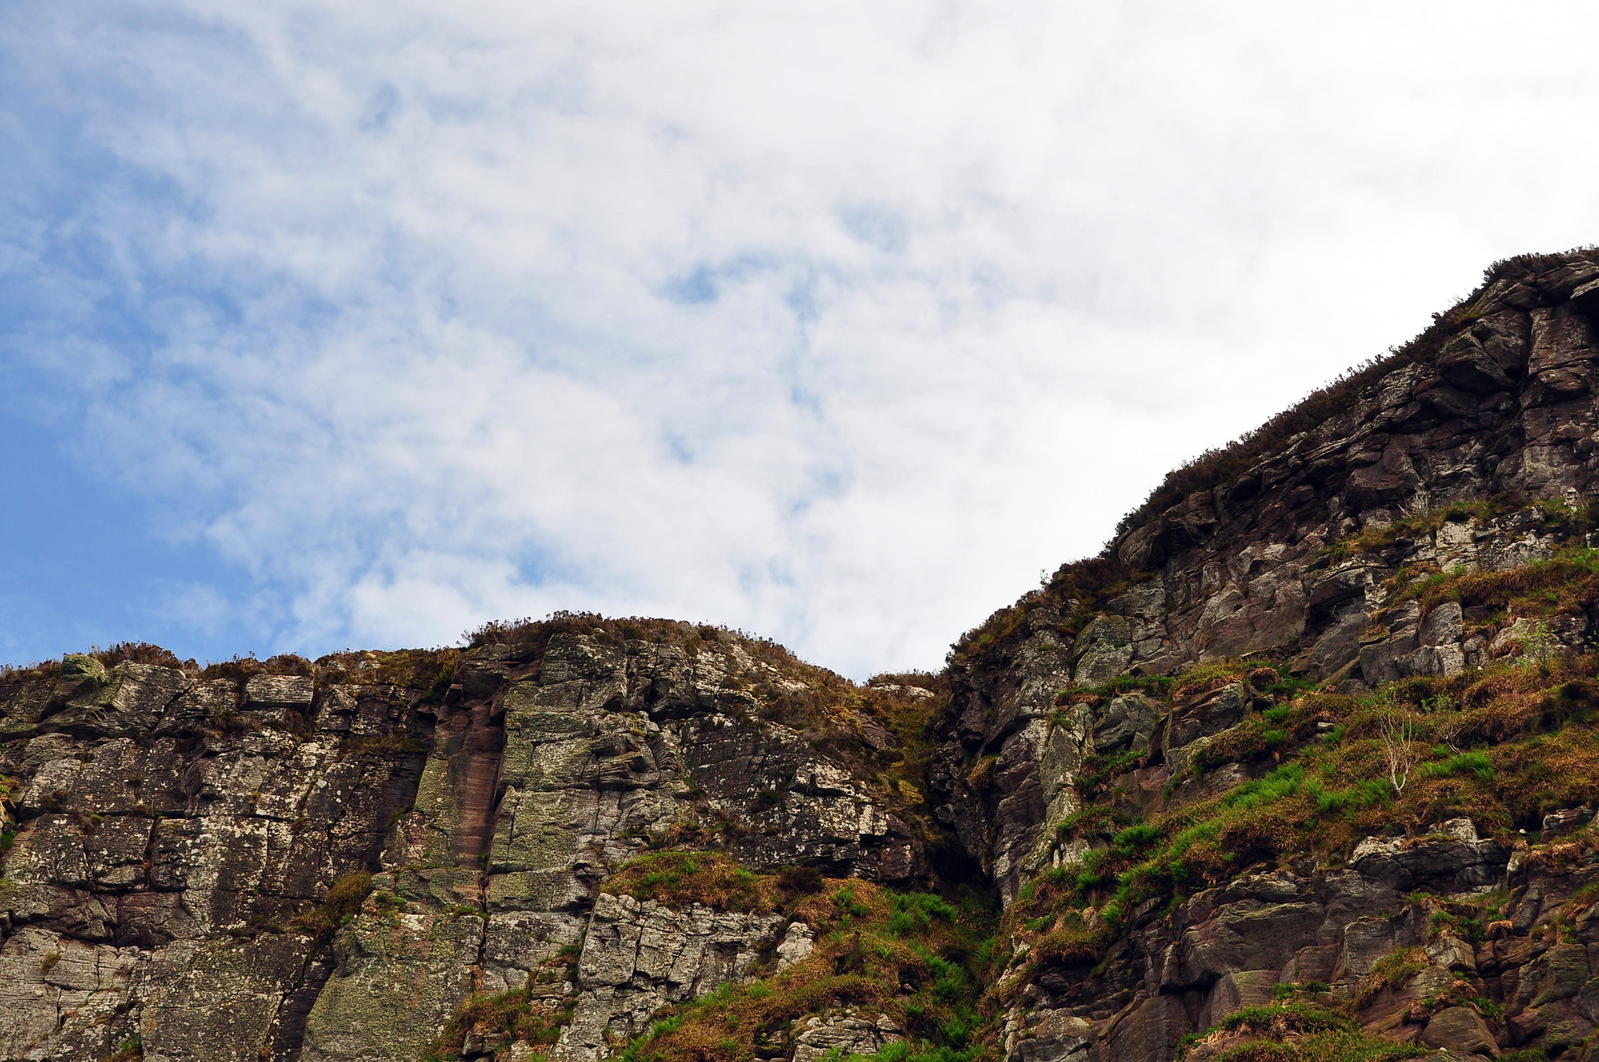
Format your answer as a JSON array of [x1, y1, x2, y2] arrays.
[[1006, 639, 1599, 1010]]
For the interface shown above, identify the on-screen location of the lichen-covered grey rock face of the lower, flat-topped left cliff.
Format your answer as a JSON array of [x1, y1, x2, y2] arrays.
[[0, 624, 926, 1060]]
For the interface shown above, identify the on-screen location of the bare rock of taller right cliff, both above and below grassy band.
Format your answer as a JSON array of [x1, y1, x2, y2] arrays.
[[932, 254, 1599, 1062]]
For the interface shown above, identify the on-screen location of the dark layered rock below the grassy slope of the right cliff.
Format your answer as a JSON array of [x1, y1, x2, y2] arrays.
[[1004, 822, 1599, 1060]]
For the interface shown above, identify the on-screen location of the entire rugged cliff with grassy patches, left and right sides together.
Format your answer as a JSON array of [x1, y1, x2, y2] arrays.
[[9, 253, 1599, 1062]]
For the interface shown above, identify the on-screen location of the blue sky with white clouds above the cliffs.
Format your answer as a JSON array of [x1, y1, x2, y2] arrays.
[[0, 0, 1599, 678]]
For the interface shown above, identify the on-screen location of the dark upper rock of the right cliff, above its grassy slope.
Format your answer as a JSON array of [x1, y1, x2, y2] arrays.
[[935, 253, 1599, 892]]
